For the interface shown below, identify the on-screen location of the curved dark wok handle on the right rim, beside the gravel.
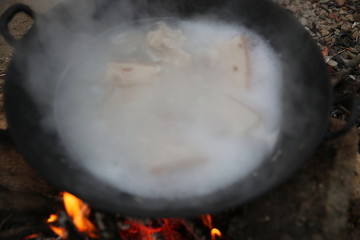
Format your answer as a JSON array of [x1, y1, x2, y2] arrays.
[[325, 96, 360, 140]]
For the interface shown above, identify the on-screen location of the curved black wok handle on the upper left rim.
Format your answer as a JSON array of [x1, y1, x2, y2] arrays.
[[0, 3, 35, 47]]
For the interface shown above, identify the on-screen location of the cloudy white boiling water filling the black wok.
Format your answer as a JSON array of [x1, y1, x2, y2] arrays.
[[56, 20, 282, 199]]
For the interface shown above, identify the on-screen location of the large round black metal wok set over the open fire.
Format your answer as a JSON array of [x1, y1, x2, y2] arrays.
[[1, 0, 348, 217]]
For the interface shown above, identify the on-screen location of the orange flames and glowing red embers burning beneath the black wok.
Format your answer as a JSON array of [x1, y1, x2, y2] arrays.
[[47, 192, 223, 240]]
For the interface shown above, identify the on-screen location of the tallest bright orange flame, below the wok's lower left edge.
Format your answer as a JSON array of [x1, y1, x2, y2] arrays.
[[63, 192, 99, 238]]
